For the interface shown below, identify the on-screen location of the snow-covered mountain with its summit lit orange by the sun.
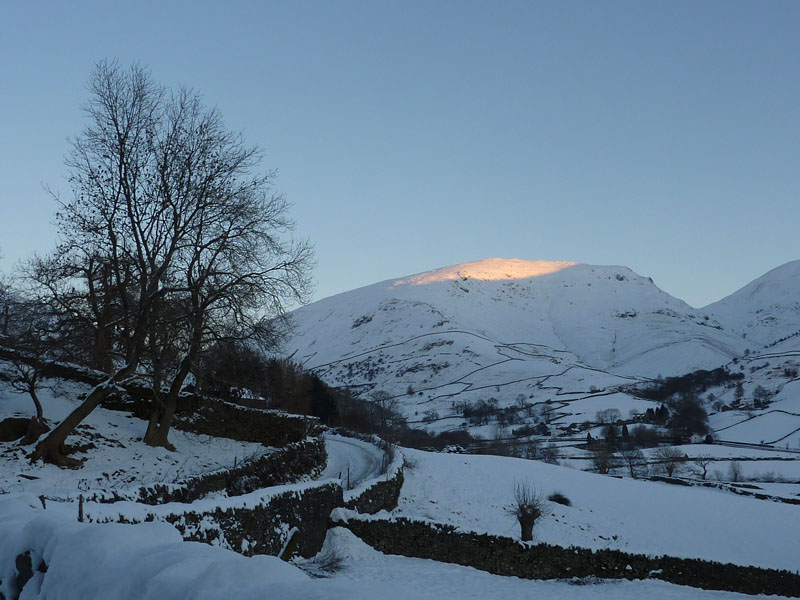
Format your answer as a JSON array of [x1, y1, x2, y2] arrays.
[[286, 258, 747, 426]]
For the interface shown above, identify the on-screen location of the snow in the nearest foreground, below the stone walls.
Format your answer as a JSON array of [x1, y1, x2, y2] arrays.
[[0, 498, 792, 600]]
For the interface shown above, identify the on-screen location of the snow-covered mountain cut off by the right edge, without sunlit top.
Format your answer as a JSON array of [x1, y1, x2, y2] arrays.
[[703, 260, 800, 350]]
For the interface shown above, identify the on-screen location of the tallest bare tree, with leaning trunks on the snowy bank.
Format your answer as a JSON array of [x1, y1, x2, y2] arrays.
[[33, 62, 312, 466]]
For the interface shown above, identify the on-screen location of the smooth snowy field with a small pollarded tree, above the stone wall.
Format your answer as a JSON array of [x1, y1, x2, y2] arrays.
[[395, 450, 800, 570]]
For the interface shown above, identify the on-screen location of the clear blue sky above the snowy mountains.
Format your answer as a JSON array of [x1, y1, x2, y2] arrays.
[[0, 0, 800, 306]]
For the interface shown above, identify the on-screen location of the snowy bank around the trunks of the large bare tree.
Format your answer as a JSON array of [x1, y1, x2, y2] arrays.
[[0, 382, 272, 499]]
